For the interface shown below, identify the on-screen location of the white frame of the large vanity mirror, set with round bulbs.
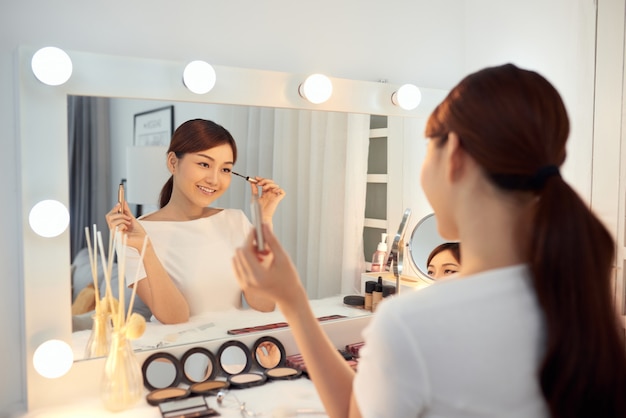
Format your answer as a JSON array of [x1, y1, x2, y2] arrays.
[[15, 46, 443, 410]]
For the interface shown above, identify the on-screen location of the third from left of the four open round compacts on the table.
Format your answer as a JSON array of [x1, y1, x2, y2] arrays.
[[217, 340, 267, 389]]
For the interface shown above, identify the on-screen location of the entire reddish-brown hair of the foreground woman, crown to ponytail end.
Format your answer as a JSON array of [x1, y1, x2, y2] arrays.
[[426, 64, 626, 418]]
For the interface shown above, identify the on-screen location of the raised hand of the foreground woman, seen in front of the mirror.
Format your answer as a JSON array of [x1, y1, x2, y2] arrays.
[[233, 224, 308, 312]]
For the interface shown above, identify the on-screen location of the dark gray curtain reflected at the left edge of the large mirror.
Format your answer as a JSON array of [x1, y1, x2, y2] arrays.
[[67, 96, 111, 260]]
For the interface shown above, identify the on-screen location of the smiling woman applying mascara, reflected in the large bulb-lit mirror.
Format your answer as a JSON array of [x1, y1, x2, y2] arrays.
[[106, 119, 285, 324]]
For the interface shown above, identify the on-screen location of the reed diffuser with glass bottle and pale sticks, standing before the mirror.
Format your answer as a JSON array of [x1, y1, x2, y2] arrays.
[[91, 230, 147, 412]]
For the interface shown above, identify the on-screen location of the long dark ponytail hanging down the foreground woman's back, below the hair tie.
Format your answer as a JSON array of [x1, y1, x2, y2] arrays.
[[529, 177, 626, 418]]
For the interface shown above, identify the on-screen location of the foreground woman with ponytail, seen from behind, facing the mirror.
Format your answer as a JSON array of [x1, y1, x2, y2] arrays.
[[233, 64, 626, 417]]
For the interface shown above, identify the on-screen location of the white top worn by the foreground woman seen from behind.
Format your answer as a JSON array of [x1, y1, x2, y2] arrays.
[[354, 265, 549, 418]]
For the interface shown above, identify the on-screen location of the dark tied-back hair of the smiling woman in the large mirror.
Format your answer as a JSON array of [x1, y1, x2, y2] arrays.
[[159, 119, 237, 208]]
